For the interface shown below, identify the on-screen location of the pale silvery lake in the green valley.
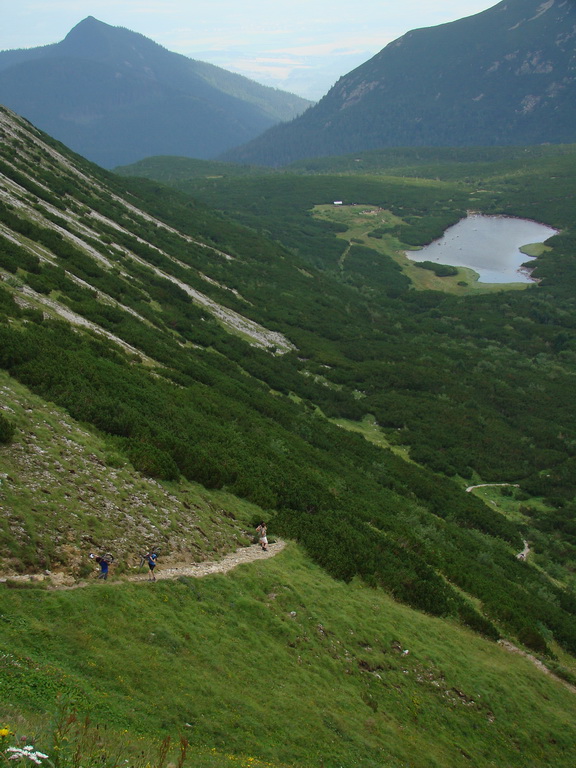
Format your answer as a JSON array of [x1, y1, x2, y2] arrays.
[[406, 214, 557, 283]]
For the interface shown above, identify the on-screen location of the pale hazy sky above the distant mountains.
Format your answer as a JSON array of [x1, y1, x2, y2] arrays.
[[0, 0, 496, 99]]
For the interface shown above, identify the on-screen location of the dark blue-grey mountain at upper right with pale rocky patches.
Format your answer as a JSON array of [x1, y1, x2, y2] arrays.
[[221, 0, 576, 165]]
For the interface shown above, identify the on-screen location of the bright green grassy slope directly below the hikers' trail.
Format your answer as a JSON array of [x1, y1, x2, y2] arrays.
[[0, 545, 576, 768]]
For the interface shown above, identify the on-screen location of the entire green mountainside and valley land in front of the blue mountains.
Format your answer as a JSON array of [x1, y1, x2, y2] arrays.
[[0, 108, 576, 768]]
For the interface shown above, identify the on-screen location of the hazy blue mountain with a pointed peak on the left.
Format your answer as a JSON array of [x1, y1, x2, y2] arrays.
[[0, 16, 309, 167]]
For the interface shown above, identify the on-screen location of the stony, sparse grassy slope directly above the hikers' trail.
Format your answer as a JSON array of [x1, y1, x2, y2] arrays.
[[0, 371, 262, 576]]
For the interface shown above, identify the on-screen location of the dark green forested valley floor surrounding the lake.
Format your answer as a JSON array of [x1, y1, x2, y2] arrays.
[[117, 146, 576, 616]]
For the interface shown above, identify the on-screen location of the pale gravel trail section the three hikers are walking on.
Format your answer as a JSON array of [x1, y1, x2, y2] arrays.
[[0, 539, 286, 590]]
